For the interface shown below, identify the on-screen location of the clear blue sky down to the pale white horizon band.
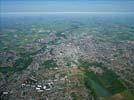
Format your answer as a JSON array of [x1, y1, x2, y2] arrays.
[[0, 0, 134, 13]]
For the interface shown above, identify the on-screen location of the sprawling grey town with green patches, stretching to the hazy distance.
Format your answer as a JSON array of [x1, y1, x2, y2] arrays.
[[0, 14, 134, 100]]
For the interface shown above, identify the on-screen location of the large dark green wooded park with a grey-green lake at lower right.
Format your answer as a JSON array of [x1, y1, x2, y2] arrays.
[[79, 59, 126, 97]]
